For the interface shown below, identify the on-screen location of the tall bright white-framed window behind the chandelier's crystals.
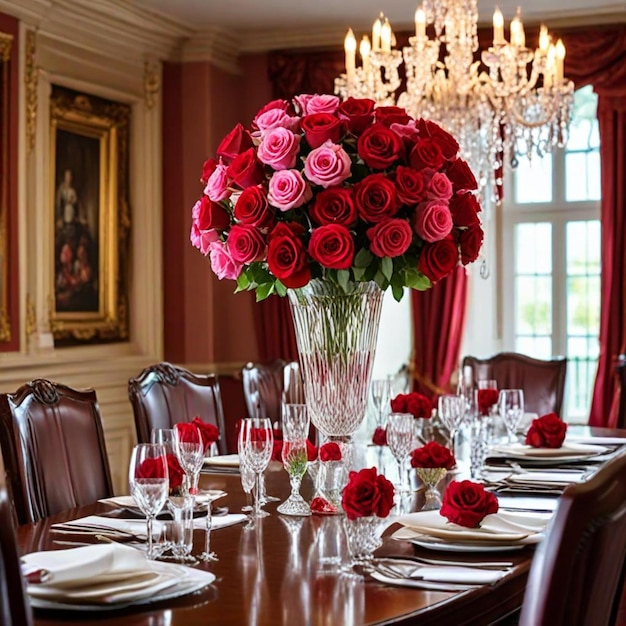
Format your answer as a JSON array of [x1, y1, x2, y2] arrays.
[[503, 87, 600, 422]]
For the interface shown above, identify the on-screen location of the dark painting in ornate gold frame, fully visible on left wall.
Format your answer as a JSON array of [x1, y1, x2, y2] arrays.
[[50, 86, 130, 345]]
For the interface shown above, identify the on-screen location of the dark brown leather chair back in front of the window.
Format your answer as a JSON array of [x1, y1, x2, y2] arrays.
[[463, 352, 567, 416]]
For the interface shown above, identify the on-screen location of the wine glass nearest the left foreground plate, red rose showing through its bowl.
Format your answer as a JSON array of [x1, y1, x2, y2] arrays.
[[128, 443, 169, 559]]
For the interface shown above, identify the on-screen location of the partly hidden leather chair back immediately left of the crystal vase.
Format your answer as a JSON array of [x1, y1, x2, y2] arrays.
[[241, 359, 286, 423]]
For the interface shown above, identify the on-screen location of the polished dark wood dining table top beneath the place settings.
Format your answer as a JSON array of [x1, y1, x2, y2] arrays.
[[17, 428, 626, 626]]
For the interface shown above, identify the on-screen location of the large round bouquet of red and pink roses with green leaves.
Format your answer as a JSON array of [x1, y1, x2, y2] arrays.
[[191, 94, 483, 300]]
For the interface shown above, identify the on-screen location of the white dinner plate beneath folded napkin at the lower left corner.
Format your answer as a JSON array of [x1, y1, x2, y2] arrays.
[[28, 562, 215, 612]]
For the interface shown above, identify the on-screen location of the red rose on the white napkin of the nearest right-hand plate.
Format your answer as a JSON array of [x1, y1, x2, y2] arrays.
[[440, 480, 498, 528]]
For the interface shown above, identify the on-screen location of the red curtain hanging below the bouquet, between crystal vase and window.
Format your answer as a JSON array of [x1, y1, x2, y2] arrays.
[[411, 267, 467, 396]]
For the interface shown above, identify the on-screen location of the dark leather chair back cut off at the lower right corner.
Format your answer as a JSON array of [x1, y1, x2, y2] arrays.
[[519, 451, 626, 626]]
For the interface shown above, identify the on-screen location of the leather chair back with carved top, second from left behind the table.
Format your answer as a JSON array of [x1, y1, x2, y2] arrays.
[[128, 362, 226, 454]]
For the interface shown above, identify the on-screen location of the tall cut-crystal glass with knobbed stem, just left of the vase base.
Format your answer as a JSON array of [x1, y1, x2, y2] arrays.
[[278, 403, 311, 515]]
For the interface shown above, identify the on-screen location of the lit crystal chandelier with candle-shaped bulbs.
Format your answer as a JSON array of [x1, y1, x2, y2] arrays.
[[335, 0, 574, 202]]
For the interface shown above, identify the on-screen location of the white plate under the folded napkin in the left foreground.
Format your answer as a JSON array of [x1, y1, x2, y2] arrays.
[[30, 562, 215, 612]]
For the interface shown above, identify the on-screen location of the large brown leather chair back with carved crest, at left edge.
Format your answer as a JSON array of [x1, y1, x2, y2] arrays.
[[0, 379, 113, 524]]
